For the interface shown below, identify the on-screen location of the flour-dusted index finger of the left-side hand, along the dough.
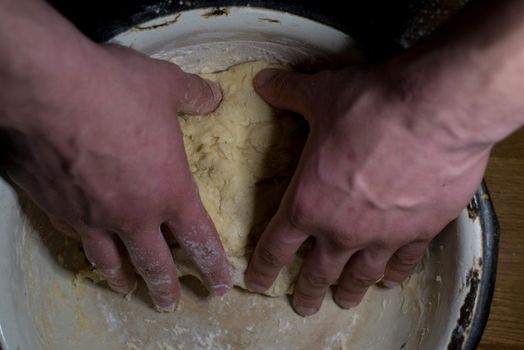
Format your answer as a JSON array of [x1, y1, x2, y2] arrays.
[[166, 204, 233, 295]]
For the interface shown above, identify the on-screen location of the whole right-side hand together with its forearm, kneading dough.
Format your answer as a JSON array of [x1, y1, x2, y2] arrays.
[[246, 0, 524, 315]]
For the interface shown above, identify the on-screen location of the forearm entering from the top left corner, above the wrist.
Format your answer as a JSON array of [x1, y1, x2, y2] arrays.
[[0, 0, 94, 128]]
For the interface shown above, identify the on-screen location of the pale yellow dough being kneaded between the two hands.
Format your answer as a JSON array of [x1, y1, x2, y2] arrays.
[[174, 62, 307, 296]]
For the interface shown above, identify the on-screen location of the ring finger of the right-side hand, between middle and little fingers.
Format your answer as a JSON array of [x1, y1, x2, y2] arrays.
[[334, 250, 391, 309]]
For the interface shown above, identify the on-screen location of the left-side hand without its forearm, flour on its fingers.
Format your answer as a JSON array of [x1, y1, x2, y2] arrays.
[[2, 45, 231, 311]]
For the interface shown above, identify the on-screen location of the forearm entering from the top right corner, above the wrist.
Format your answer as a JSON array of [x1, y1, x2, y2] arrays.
[[387, 0, 524, 148]]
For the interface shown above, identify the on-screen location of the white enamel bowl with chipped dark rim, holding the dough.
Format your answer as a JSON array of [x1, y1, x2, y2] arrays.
[[0, 7, 498, 350]]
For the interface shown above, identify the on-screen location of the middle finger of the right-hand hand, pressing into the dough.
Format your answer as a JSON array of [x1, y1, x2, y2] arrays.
[[293, 241, 351, 316]]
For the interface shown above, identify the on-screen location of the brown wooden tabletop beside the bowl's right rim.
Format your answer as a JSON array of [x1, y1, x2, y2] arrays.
[[479, 129, 524, 350]]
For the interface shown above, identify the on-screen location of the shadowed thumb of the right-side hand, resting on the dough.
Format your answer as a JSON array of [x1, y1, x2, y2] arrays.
[[255, 69, 313, 116]]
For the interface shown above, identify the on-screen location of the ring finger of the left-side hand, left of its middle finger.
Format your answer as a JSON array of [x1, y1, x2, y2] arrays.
[[79, 228, 136, 294]]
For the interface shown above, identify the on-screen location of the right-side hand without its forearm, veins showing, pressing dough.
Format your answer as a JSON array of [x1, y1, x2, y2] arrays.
[[246, 67, 490, 316]]
